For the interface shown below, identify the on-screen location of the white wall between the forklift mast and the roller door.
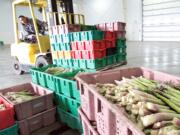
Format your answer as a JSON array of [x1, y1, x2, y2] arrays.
[[74, 0, 142, 41]]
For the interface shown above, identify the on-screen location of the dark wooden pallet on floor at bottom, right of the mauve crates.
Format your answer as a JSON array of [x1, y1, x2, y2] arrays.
[[31, 122, 70, 135]]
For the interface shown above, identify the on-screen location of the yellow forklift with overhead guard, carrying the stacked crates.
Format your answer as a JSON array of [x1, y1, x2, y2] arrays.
[[11, 0, 73, 75]]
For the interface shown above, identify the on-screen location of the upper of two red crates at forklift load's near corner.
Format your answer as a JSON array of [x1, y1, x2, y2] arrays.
[[83, 40, 106, 50]]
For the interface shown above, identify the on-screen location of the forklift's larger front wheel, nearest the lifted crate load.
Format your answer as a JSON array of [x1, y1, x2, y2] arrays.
[[35, 56, 52, 68]]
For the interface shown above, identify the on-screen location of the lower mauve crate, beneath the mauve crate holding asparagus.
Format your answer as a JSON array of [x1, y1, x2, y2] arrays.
[[18, 108, 56, 135]]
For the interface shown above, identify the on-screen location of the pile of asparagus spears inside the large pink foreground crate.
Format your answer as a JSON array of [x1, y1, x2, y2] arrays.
[[96, 77, 180, 135]]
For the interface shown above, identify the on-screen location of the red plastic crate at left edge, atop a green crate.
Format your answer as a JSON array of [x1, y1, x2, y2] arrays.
[[0, 96, 15, 130]]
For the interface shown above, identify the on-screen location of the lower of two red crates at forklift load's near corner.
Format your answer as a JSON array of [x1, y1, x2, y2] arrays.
[[82, 49, 106, 59]]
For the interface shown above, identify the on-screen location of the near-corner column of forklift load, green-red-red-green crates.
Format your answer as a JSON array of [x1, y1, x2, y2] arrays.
[[71, 30, 106, 69]]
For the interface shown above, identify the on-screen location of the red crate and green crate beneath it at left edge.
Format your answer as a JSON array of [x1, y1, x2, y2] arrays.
[[0, 96, 18, 135]]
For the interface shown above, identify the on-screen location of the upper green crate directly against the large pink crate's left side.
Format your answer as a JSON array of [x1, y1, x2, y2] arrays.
[[54, 70, 80, 101]]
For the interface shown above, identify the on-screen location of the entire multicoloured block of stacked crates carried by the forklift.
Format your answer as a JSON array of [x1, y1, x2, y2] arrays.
[[50, 22, 126, 69]]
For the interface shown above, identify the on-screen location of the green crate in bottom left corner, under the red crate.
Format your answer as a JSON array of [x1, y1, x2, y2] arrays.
[[0, 124, 19, 135]]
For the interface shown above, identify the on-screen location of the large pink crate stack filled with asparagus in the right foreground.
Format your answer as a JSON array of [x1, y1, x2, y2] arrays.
[[76, 68, 180, 135]]
